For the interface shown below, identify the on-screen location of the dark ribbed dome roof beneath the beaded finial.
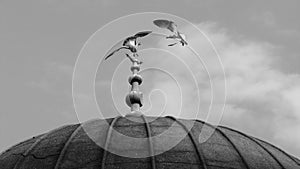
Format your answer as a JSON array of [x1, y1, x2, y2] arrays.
[[0, 116, 300, 169]]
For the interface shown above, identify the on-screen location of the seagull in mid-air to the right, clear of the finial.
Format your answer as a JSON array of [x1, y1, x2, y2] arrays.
[[153, 19, 188, 46]]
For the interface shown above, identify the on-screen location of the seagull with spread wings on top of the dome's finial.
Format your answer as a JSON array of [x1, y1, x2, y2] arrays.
[[104, 31, 152, 60]]
